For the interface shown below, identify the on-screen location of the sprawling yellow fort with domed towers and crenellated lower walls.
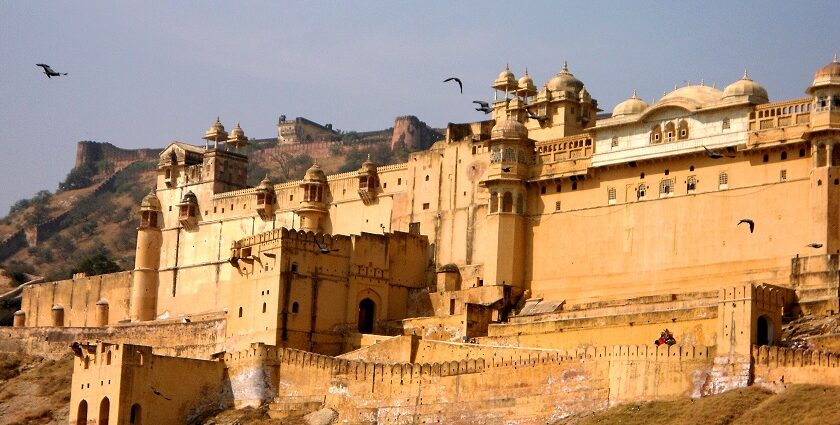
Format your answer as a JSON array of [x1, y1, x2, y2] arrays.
[[0, 58, 840, 424]]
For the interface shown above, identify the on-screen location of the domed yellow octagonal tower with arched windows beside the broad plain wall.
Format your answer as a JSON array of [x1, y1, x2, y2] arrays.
[[481, 117, 534, 287]]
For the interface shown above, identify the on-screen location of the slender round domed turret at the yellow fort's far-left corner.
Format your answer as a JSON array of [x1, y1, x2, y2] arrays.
[[128, 192, 162, 320]]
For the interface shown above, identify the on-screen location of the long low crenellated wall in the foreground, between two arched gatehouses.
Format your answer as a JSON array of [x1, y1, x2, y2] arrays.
[[225, 345, 714, 423]]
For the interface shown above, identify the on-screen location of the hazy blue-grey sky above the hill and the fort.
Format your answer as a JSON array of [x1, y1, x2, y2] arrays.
[[0, 0, 840, 216]]
